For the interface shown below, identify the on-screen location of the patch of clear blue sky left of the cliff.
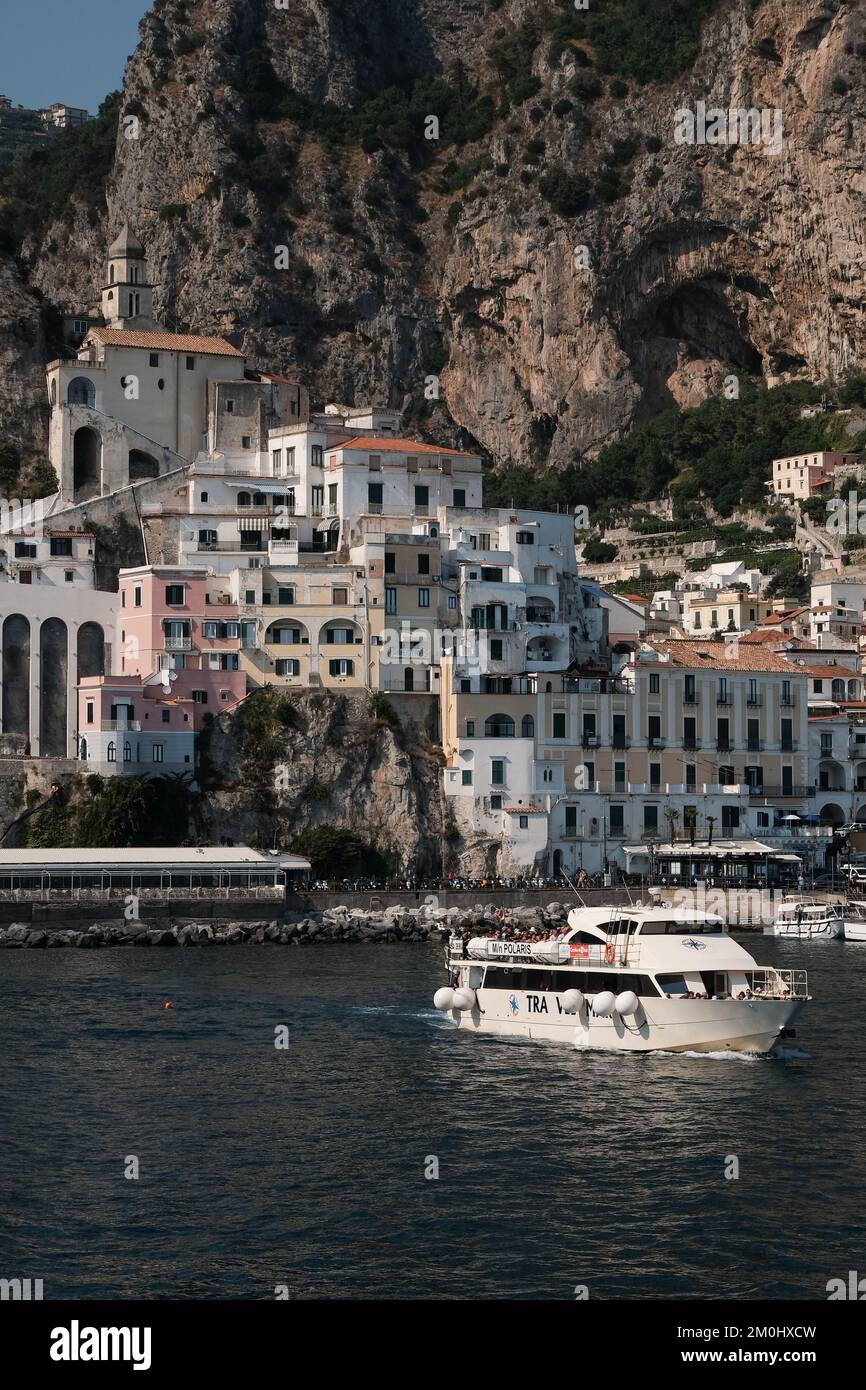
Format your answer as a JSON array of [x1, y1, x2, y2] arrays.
[[0, 0, 150, 111]]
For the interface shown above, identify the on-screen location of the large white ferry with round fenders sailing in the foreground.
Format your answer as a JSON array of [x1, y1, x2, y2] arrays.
[[434, 904, 809, 1052]]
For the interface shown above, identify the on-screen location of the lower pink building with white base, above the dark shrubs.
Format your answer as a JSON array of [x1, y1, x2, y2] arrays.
[[78, 673, 196, 776]]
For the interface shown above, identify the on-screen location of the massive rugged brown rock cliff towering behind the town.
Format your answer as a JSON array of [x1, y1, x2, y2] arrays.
[[0, 0, 866, 486]]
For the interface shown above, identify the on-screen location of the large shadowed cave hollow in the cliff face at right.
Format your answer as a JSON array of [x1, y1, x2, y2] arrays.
[[627, 279, 763, 418]]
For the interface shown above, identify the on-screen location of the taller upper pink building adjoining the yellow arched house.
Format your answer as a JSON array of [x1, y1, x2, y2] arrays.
[[117, 566, 246, 731]]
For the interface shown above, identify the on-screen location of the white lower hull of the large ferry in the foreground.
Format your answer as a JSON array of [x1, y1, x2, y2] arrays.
[[450, 988, 805, 1052]]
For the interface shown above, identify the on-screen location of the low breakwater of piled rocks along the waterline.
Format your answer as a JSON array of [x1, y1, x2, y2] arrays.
[[0, 902, 569, 951]]
